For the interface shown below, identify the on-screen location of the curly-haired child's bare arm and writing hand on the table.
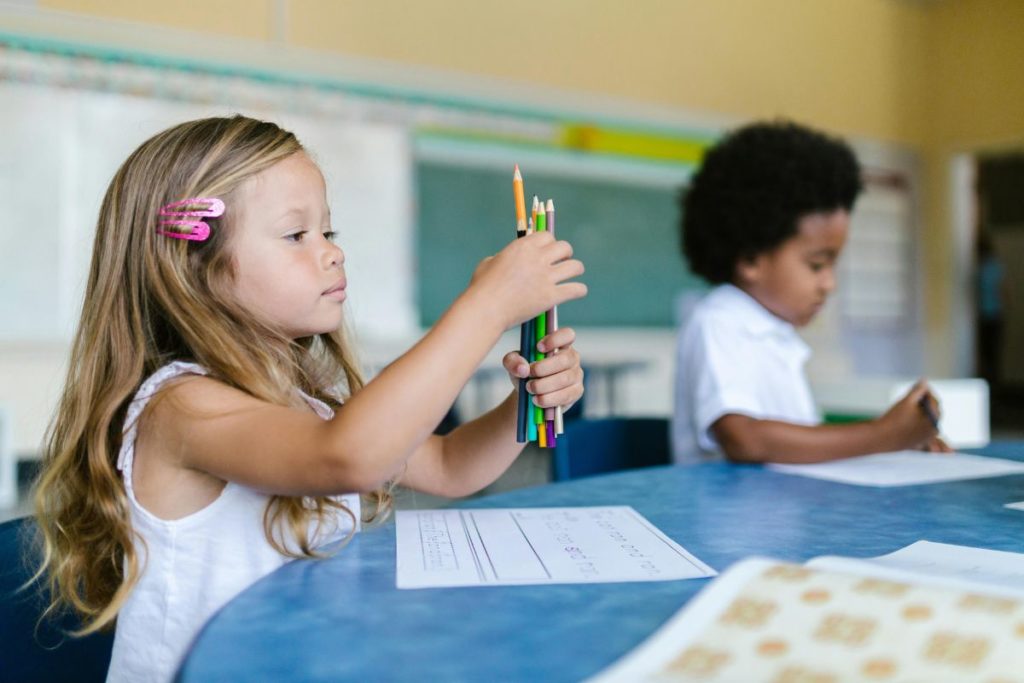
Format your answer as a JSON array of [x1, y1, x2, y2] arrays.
[[712, 383, 949, 463]]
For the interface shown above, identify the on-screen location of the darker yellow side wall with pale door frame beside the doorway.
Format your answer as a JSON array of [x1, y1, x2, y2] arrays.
[[922, 0, 1024, 376]]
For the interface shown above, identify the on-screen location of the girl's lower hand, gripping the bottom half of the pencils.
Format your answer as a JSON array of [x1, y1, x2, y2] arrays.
[[502, 328, 583, 410]]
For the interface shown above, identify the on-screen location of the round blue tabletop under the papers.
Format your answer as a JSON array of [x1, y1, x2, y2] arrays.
[[174, 443, 1024, 681]]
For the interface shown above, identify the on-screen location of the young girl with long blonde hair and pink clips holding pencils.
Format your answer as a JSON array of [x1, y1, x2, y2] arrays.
[[36, 117, 587, 681]]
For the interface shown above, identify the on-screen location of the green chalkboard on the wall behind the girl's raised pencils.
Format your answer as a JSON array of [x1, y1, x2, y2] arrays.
[[416, 162, 703, 327]]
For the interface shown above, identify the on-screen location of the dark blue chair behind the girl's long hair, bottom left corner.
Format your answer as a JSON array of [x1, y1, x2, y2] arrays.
[[0, 517, 114, 682]]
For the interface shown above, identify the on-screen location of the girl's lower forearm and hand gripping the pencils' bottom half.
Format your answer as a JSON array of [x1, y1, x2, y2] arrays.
[[400, 328, 583, 498]]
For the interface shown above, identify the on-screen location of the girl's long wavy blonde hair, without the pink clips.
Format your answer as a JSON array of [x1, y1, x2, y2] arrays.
[[35, 116, 390, 635]]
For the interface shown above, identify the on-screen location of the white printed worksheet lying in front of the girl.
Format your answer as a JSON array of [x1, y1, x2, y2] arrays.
[[395, 506, 716, 588]]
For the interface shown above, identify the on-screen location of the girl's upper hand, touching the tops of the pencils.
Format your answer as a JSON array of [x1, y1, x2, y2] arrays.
[[466, 232, 587, 330]]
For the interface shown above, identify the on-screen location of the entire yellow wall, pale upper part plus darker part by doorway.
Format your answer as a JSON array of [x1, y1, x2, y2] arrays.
[[25, 0, 1024, 373]]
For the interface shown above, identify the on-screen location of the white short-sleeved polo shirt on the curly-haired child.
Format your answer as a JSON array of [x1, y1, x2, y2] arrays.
[[672, 285, 820, 463]]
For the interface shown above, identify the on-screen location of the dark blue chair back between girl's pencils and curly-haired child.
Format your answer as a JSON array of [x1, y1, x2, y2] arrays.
[[551, 418, 672, 481]]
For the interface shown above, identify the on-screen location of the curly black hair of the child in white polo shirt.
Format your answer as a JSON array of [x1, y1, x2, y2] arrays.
[[680, 121, 861, 284]]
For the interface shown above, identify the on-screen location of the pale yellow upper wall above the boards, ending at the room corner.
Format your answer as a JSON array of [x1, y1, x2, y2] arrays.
[[40, 0, 927, 142]]
